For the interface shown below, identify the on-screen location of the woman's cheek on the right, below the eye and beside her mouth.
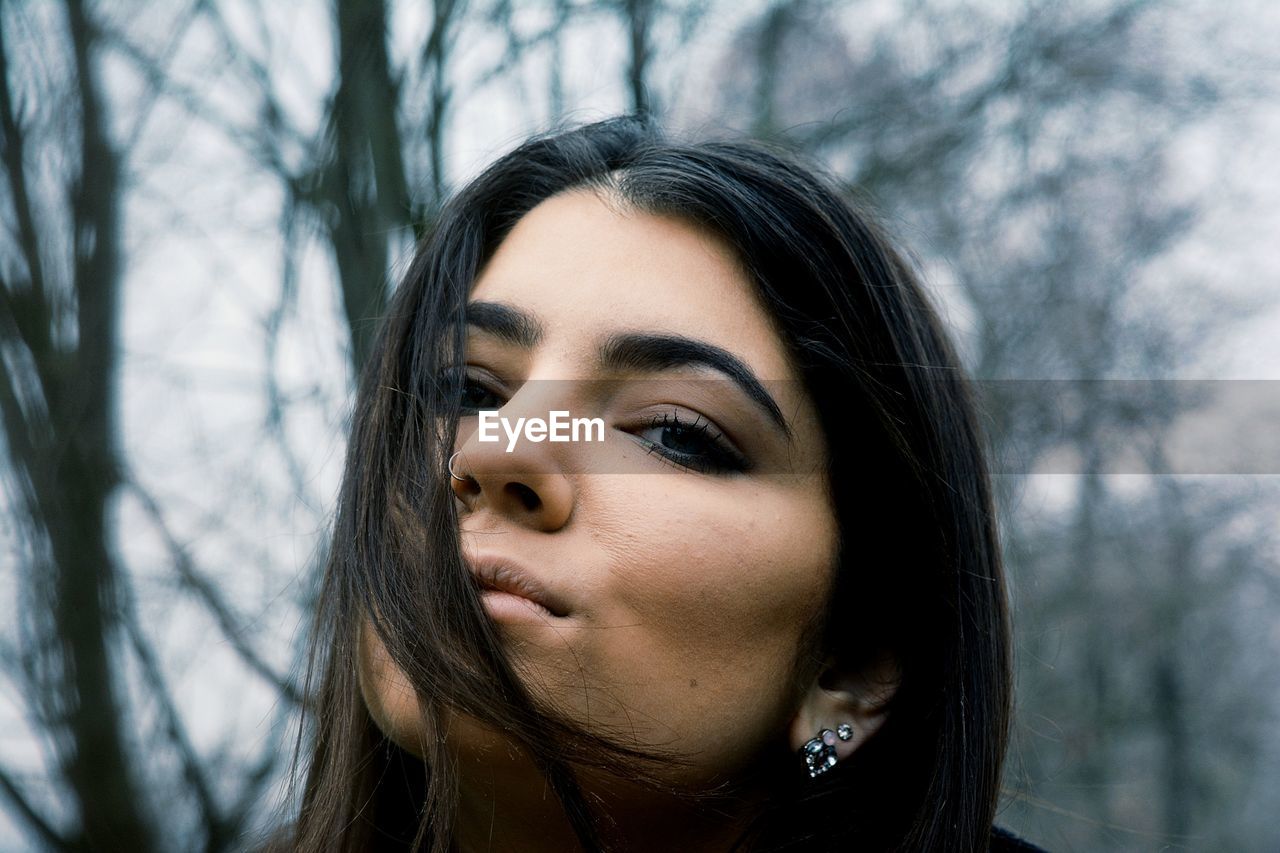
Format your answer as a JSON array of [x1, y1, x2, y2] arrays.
[[573, 478, 837, 767]]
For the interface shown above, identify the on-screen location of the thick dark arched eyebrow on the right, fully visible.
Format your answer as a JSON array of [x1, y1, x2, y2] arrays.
[[600, 332, 792, 439]]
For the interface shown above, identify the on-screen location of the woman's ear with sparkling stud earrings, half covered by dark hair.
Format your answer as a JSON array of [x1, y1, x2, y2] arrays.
[[791, 654, 901, 760]]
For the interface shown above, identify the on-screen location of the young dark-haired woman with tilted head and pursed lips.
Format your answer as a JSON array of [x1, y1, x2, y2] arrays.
[[292, 118, 1044, 853]]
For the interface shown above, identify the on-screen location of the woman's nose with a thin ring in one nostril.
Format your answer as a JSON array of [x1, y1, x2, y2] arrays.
[[449, 409, 573, 533]]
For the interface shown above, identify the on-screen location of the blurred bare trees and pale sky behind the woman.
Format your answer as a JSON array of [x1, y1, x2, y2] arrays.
[[0, 0, 1280, 852]]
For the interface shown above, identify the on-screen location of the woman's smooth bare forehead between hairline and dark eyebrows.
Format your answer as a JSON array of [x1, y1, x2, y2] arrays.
[[471, 190, 796, 379]]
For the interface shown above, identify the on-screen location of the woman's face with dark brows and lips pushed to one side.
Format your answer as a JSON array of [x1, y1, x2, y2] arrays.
[[364, 191, 838, 783]]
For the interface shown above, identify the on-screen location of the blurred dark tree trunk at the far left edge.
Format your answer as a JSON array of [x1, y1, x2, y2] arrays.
[[0, 0, 155, 850]]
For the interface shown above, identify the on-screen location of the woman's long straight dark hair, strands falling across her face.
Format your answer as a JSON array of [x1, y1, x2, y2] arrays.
[[294, 118, 1010, 853]]
